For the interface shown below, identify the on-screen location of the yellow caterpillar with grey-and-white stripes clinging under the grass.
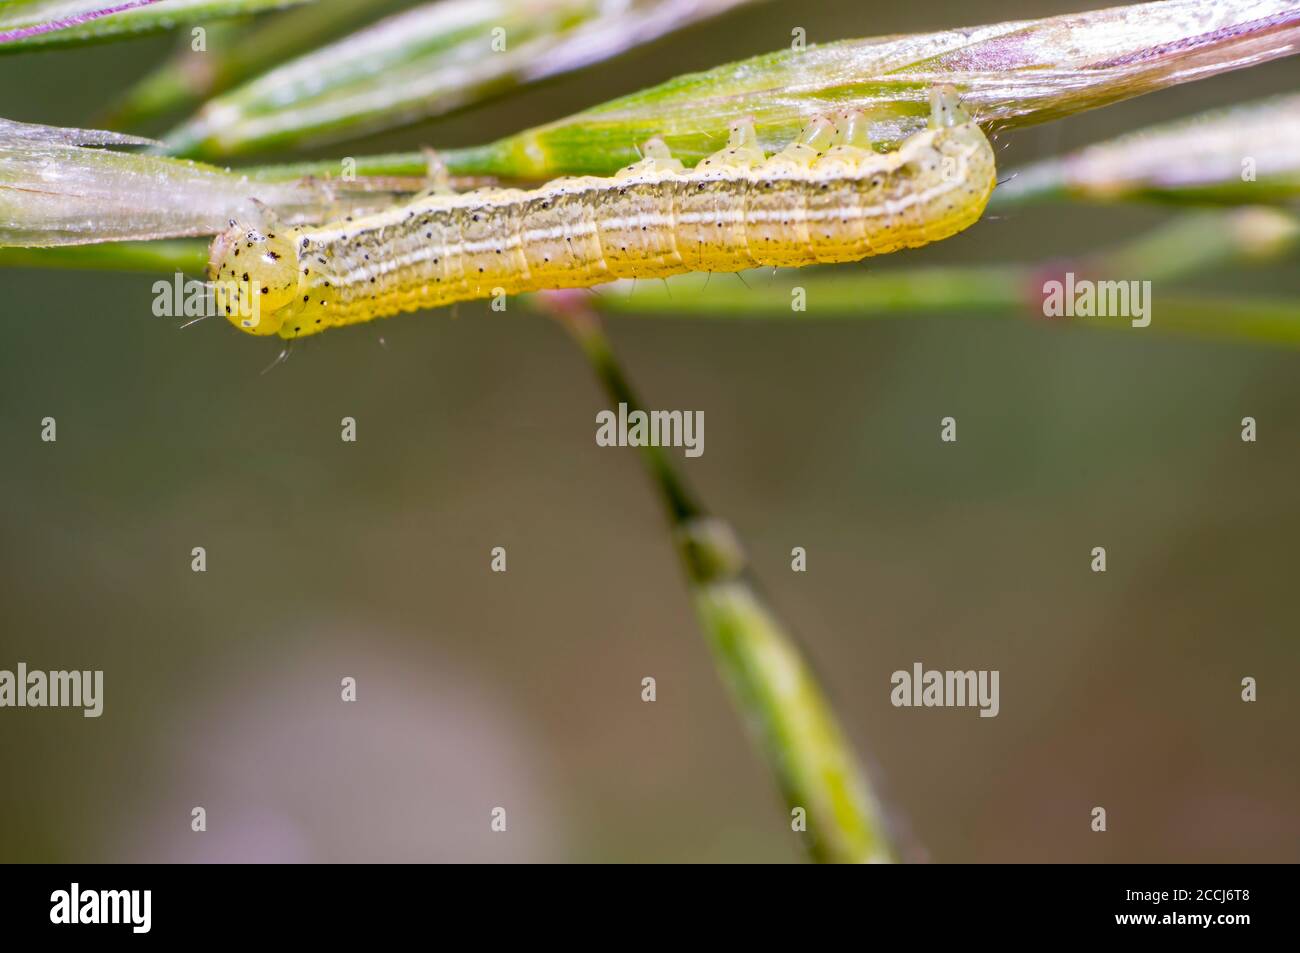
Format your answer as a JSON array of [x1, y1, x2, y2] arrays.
[[208, 87, 996, 338]]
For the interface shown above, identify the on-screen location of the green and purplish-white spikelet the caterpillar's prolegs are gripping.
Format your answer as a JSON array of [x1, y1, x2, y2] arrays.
[[244, 0, 1300, 181]]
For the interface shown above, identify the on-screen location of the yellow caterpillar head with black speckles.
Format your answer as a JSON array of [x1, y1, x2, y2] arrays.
[[208, 218, 298, 334]]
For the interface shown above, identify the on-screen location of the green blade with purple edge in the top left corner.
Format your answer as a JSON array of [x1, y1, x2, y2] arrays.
[[0, 0, 315, 53]]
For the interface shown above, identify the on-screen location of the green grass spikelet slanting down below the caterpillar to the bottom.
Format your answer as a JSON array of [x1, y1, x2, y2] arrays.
[[547, 295, 894, 863]]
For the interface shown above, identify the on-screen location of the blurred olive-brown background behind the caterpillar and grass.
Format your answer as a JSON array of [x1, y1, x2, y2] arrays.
[[0, 0, 1300, 862]]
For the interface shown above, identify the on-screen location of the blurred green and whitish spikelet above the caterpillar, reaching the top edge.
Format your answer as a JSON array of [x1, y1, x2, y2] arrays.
[[164, 0, 753, 159]]
